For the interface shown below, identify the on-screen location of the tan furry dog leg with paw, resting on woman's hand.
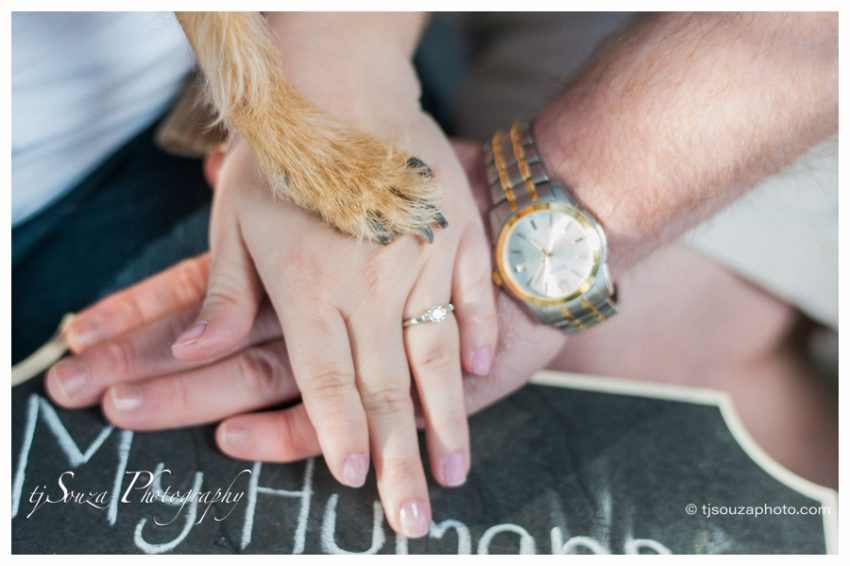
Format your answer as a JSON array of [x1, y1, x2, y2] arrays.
[[177, 12, 445, 244]]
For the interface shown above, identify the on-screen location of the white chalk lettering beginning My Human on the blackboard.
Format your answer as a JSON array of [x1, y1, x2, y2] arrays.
[[12, 395, 670, 554]]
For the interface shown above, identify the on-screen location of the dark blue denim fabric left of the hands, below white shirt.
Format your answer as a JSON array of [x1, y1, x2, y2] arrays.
[[12, 122, 212, 363]]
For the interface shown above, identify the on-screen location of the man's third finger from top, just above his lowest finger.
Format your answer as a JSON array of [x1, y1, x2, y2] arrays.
[[102, 340, 298, 430]]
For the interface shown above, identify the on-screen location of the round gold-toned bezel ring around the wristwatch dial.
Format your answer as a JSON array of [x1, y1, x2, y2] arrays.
[[496, 201, 606, 307]]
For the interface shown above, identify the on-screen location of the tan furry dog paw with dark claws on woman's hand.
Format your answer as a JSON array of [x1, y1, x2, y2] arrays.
[[249, 112, 448, 245]]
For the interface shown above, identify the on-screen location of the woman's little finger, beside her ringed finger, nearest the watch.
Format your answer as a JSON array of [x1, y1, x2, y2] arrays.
[[452, 225, 499, 376]]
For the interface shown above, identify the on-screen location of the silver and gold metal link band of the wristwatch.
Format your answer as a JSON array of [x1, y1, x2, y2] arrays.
[[485, 122, 617, 332]]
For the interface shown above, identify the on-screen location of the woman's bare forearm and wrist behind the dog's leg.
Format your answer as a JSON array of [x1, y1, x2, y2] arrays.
[[266, 12, 426, 133]]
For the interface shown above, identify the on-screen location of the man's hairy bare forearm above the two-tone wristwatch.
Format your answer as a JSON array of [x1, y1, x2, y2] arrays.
[[535, 13, 838, 274]]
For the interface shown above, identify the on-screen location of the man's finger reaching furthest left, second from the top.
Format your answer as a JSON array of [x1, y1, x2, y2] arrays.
[[45, 303, 281, 408]]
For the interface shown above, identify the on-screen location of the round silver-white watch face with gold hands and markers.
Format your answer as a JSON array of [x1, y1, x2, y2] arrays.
[[498, 203, 602, 304]]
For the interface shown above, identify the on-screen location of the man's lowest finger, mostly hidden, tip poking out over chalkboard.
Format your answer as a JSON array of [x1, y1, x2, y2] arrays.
[[215, 404, 321, 462]]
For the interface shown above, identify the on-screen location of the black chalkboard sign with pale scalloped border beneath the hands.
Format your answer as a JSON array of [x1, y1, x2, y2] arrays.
[[12, 372, 837, 554]]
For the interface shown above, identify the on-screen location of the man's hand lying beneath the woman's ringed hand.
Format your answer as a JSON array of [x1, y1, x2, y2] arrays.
[[47, 144, 564, 532]]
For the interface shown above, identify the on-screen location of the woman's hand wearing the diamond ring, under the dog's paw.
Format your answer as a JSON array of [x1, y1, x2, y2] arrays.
[[51, 120, 497, 536]]
